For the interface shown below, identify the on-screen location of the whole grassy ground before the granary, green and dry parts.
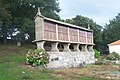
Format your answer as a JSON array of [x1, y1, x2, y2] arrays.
[[0, 44, 119, 80]]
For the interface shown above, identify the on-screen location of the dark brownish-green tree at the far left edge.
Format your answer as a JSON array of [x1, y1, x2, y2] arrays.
[[0, 0, 11, 43]]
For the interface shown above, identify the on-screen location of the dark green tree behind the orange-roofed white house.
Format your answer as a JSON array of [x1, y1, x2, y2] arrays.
[[103, 13, 120, 53]]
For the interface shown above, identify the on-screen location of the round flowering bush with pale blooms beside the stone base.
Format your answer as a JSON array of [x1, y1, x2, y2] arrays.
[[26, 49, 49, 67]]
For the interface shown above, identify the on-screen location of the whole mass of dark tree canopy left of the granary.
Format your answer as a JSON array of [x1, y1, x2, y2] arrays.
[[0, 0, 60, 42]]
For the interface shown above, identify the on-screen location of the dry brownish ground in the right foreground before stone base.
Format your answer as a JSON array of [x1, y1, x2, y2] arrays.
[[55, 65, 120, 80]]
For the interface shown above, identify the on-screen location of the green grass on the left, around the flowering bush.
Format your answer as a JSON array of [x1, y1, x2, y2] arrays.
[[0, 45, 103, 80]]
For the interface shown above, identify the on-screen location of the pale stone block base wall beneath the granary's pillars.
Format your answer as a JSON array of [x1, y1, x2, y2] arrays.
[[47, 52, 95, 68]]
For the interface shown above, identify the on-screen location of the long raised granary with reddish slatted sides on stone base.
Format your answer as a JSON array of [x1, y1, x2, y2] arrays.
[[35, 9, 95, 68]]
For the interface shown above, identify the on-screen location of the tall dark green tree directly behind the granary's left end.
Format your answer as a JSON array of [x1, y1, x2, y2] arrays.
[[1, 0, 60, 42]]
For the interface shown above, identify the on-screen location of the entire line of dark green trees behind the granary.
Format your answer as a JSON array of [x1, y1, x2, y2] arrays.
[[0, 0, 120, 54]]
